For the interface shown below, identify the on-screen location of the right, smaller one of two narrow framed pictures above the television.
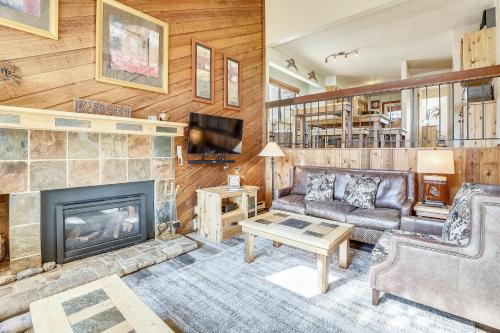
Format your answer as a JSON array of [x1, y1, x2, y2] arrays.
[[224, 56, 241, 111]]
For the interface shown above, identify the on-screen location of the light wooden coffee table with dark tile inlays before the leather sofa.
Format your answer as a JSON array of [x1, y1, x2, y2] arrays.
[[240, 210, 354, 293]]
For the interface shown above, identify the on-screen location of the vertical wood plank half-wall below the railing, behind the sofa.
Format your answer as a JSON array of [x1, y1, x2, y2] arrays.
[[266, 148, 500, 203]]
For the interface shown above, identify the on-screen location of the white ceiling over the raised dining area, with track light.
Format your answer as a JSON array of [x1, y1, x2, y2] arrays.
[[276, 0, 495, 84]]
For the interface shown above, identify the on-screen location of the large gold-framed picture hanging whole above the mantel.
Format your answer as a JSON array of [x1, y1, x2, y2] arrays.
[[96, 0, 168, 94]]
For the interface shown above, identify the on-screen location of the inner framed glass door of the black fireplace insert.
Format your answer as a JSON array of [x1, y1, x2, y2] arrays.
[[56, 195, 146, 262]]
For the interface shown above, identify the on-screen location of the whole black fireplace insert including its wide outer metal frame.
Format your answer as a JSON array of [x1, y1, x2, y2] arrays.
[[41, 181, 154, 264]]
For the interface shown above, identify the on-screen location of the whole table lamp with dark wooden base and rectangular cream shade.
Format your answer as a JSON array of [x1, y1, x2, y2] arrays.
[[417, 150, 455, 207]]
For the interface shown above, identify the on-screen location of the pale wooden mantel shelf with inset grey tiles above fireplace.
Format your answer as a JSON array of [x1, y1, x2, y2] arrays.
[[0, 105, 187, 136]]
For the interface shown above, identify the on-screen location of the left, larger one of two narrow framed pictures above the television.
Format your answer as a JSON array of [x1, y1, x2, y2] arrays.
[[192, 39, 215, 104]]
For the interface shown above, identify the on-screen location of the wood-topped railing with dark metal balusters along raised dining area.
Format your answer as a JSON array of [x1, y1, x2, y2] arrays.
[[266, 65, 500, 148]]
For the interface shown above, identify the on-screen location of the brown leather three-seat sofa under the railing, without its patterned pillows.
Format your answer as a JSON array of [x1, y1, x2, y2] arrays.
[[273, 166, 415, 244]]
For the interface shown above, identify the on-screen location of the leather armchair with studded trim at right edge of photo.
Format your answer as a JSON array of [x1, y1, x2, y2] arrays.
[[370, 185, 500, 329]]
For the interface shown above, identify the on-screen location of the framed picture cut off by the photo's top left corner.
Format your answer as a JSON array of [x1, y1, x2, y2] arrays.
[[0, 0, 58, 39]]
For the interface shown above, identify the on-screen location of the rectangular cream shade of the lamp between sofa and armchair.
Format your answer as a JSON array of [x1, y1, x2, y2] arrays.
[[417, 150, 455, 175]]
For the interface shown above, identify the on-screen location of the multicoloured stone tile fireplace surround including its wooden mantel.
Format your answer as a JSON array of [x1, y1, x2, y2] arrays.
[[0, 107, 184, 274]]
